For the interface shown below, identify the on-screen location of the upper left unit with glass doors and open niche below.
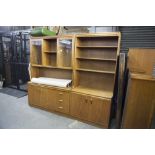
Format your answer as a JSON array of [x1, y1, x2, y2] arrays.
[[30, 35, 74, 83]]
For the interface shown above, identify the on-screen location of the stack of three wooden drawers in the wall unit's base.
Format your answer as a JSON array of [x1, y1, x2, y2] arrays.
[[55, 91, 70, 114]]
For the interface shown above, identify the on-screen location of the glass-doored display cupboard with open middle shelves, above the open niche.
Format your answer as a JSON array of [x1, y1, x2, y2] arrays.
[[31, 35, 74, 69]]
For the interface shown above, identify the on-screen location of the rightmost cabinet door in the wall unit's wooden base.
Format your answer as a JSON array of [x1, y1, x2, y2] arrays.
[[89, 97, 111, 128]]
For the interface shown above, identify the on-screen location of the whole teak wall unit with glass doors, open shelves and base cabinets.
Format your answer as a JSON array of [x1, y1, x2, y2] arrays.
[[28, 32, 120, 128]]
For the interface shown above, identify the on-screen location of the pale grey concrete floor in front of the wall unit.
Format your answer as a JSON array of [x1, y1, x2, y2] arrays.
[[0, 93, 97, 129]]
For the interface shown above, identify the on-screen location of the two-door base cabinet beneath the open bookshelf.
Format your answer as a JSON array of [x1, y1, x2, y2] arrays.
[[70, 93, 111, 128]]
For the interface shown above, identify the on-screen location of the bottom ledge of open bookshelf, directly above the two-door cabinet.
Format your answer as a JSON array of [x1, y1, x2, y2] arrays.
[[72, 86, 113, 98]]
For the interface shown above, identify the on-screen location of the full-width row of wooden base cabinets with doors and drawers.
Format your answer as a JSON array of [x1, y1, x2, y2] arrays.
[[28, 83, 111, 128]]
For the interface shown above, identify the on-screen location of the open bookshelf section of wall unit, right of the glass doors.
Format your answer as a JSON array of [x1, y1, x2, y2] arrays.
[[73, 32, 120, 98]]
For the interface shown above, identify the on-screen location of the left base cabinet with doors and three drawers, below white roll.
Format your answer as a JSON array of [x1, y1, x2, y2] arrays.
[[28, 84, 69, 114]]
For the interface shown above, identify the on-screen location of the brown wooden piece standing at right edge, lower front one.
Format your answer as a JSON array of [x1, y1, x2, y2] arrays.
[[122, 74, 155, 129]]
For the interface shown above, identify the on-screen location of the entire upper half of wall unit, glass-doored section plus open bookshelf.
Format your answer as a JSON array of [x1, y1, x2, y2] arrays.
[[31, 32, 120, 98]]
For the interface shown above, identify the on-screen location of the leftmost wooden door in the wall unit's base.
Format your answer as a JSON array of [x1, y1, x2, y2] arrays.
[[28, 84, 41, 106]]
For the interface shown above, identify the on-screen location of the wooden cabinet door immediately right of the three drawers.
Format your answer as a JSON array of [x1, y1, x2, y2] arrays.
[[70, 93, 89, 120]]
